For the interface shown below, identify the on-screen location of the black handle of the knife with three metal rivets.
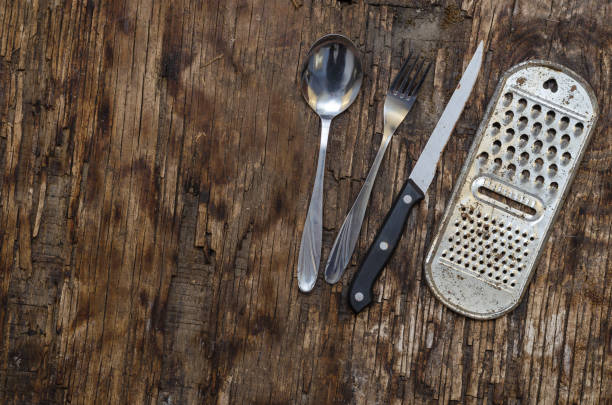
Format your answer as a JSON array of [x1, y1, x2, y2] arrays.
[[349, 179, 425, 313]]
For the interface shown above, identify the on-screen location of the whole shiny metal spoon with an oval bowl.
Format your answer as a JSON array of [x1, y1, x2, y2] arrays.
[[298, 34, 363, 292]]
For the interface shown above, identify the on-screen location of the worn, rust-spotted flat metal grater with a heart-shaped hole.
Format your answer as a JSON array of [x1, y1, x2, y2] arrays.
[[425, 61, 597, 319]]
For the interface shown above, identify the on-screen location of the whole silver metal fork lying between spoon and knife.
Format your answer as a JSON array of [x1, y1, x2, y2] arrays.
[[325, 51, 431, 284]]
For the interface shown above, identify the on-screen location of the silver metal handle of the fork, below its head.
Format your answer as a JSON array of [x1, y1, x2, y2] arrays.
[[325, 136, 391, 284]]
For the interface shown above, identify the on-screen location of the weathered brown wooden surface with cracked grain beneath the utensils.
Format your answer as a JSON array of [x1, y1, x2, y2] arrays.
[[0, 0, 612, 404]]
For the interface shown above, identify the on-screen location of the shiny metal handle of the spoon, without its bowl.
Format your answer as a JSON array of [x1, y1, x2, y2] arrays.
[[298, 118, 331, 292]]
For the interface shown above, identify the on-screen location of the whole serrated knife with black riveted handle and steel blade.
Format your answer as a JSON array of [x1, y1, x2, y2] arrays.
[[349, 41, 483, 313]]
